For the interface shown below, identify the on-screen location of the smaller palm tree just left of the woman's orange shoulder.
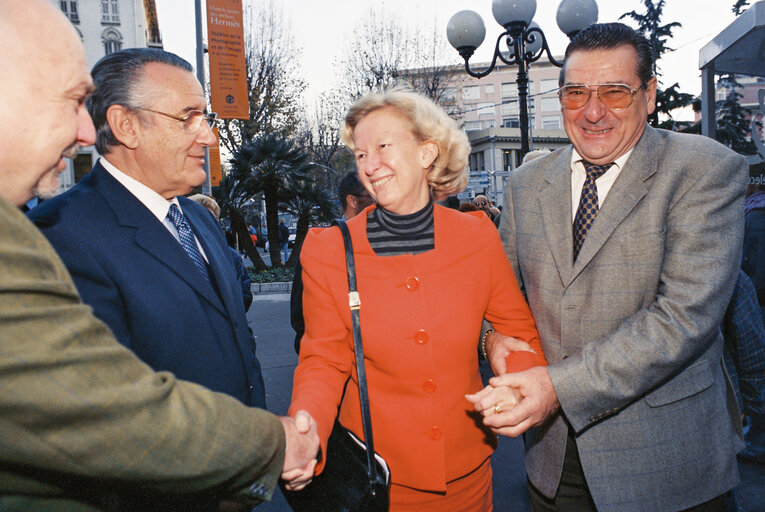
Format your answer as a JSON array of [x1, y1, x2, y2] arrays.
[[282, 179, 338, 267]]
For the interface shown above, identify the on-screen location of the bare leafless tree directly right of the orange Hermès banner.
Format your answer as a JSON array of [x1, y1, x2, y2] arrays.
[[215, 0, 305, 153]]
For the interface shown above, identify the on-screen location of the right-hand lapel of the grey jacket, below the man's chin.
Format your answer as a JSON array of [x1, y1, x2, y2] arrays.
[[566, 126, 659, 285]]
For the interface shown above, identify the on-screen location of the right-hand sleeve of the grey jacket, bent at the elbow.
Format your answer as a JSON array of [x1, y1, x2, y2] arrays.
[[549, 152, 747, 432]]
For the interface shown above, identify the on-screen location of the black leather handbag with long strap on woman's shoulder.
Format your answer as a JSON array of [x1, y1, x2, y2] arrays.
[[281, 219, 390, 512]]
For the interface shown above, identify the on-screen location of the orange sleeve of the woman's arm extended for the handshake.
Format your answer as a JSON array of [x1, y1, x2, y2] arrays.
[[289, 229, 354, 471]]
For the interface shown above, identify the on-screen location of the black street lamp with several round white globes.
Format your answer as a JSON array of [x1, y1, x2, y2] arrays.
[[446, 0, 598, 157]]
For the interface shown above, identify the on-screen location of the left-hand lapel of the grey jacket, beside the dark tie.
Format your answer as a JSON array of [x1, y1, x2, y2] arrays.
[[539, 149, 574, 286]]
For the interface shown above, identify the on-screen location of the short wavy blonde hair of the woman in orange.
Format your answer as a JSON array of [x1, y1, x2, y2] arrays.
[[340, 88, 470, 200]]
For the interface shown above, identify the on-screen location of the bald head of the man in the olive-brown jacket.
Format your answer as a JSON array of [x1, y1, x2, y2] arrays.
[[0, 0, 95, 205]]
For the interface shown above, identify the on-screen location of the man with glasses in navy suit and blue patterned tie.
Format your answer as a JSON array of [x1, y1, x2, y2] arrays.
[[29, 48, 265, 408]]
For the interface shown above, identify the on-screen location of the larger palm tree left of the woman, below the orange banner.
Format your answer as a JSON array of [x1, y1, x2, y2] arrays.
[[230, 133, 311, 267]]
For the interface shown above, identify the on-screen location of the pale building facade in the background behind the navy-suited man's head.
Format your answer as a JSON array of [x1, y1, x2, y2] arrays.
[[50, 0, 162, 191]]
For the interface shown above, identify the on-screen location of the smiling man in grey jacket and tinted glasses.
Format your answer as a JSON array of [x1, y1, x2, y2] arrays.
[[471, 23, 747, 512]]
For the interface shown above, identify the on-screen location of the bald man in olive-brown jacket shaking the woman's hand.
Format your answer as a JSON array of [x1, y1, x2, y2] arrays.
[[0, 0, 319, 512]]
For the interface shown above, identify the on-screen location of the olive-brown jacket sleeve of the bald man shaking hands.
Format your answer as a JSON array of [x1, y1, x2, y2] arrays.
[[0, 200, 285, 501]]
